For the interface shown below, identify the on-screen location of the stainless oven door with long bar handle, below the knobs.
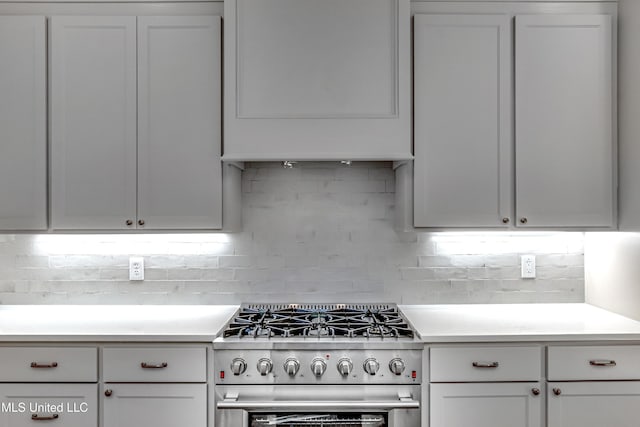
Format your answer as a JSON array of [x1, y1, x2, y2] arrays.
[[215, 385, 420, 427]]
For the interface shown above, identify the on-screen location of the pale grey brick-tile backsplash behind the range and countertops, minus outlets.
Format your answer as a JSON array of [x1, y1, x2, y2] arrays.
[[0, 162, 585, 304]]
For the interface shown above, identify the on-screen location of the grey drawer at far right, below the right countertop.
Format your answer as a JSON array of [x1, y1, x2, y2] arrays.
[[548, 346, 640, 381]]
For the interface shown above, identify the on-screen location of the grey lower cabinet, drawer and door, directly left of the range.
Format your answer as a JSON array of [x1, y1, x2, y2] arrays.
[[101, 344, 207, 427]]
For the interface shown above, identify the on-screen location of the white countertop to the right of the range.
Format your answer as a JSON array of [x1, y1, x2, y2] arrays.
[[400, 304, 640, 343]]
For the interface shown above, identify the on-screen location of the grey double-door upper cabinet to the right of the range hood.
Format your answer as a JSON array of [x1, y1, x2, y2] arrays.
[[412, 3, 617, 229]]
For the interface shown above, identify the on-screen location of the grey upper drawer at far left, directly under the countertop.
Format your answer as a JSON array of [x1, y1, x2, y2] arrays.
[[0, 347, 98, 382]]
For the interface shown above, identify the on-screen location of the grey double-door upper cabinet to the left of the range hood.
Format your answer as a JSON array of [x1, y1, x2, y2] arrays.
[[51, 16, 222, 230]]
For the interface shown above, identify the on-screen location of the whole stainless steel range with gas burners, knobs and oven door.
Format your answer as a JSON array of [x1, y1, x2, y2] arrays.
[[214, 304, 423, 427]]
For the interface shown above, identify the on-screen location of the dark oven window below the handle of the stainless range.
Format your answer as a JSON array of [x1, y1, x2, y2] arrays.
[[250, 413, 388, 427]]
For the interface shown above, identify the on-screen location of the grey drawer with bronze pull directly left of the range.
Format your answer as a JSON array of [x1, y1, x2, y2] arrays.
[[103, 347, 207, 383]]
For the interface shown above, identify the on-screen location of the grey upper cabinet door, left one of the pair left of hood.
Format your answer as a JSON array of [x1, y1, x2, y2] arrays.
[[50, 16, 136, 229]]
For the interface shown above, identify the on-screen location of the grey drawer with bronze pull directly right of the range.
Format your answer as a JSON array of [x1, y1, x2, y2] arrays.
[[430, 346, 542, 382]]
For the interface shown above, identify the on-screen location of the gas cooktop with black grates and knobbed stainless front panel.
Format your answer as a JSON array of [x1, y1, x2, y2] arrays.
[[213, 304, 424, 385]]
